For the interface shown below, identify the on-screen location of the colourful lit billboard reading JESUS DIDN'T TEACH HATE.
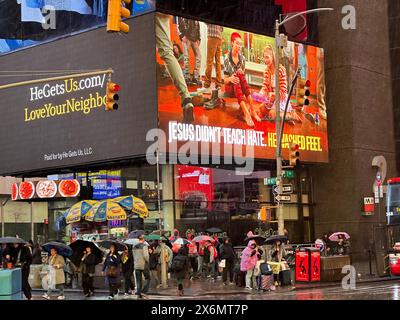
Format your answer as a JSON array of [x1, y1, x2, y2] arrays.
[[156, 13, 328, 162]]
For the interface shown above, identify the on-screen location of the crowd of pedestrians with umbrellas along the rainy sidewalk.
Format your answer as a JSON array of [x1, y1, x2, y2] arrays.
[[1, 229, 349, 300]]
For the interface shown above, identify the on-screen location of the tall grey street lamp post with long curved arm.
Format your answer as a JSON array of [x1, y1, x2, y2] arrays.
[[275, 8, 334, 235]]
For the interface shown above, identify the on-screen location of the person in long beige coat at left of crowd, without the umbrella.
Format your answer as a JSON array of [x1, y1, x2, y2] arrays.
[[43, 247, 65, 300]]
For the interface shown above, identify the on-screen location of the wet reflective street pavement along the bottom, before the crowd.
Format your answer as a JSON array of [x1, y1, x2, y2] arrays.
[[29, 279, 400, 300]]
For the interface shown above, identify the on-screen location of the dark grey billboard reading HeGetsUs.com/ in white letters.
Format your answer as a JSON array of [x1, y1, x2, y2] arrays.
[[0, 13, 157, 175]]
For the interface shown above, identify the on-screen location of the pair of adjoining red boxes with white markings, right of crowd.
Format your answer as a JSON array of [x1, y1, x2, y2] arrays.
[[295, 247, 321, 282]]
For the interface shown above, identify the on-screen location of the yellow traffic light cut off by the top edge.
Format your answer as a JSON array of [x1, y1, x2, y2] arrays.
[[107, 0, 131, 33]]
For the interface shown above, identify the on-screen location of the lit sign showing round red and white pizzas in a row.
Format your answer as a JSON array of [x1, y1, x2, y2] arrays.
[[11, 179, 81, 201]]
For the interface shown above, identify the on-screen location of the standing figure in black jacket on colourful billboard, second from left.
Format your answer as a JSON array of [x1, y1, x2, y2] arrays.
[[178, 18, 202, 86]]
